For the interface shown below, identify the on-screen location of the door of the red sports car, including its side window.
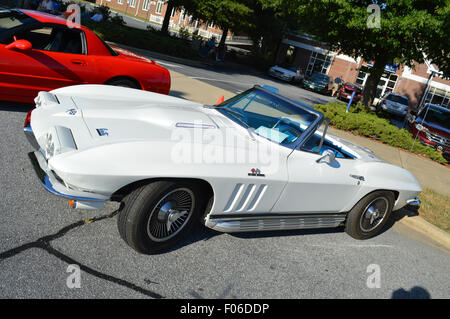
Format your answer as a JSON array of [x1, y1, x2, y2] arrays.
[[0, 24, 96, 101]]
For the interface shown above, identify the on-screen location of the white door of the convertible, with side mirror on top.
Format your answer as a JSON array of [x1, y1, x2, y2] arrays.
[[273, 122, 360, 214]]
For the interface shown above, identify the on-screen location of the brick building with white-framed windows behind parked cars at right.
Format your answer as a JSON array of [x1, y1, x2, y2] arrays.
[[277, 35, 450, 108]]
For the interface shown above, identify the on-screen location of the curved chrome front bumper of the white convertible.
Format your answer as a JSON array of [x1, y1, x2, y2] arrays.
[[28, 152, 109, 201]]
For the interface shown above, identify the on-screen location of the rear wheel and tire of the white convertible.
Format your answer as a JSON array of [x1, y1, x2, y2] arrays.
[[345, 191, 395, 239]]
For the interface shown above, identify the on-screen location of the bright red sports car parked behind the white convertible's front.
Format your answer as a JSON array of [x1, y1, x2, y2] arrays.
[[0, 10, 170, 103]]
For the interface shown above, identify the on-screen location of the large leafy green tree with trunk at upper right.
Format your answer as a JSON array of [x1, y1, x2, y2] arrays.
[[261, 0, 450, 106]]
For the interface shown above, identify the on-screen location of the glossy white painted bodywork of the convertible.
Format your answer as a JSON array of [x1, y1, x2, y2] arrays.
[[27, 85, 422, 234]]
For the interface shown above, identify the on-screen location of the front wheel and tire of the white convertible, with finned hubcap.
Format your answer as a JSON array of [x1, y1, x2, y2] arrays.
[[117, 181, 204, 254]]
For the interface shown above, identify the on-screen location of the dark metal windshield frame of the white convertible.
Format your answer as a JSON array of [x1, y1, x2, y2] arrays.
[[211, 85, 325, 150]]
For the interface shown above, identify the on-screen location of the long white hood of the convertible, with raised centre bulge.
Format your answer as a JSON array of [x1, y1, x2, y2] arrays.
[[32, 85, 251, 150]]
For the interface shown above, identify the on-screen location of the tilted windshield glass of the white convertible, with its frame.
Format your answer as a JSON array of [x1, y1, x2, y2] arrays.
[[213, 89, 319, 145]]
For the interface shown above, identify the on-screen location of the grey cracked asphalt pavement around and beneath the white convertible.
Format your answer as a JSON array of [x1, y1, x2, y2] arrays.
[[0, 67, 450, 298]]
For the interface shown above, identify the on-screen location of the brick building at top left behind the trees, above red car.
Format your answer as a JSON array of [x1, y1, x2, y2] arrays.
[[96, 0, 231, 41]]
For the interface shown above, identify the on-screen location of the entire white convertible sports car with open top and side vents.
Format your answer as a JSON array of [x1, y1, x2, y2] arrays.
[[24, 85, 421, 253]]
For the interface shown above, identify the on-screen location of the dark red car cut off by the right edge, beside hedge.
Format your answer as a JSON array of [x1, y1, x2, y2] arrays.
[[407, 104, 450, 158]]
